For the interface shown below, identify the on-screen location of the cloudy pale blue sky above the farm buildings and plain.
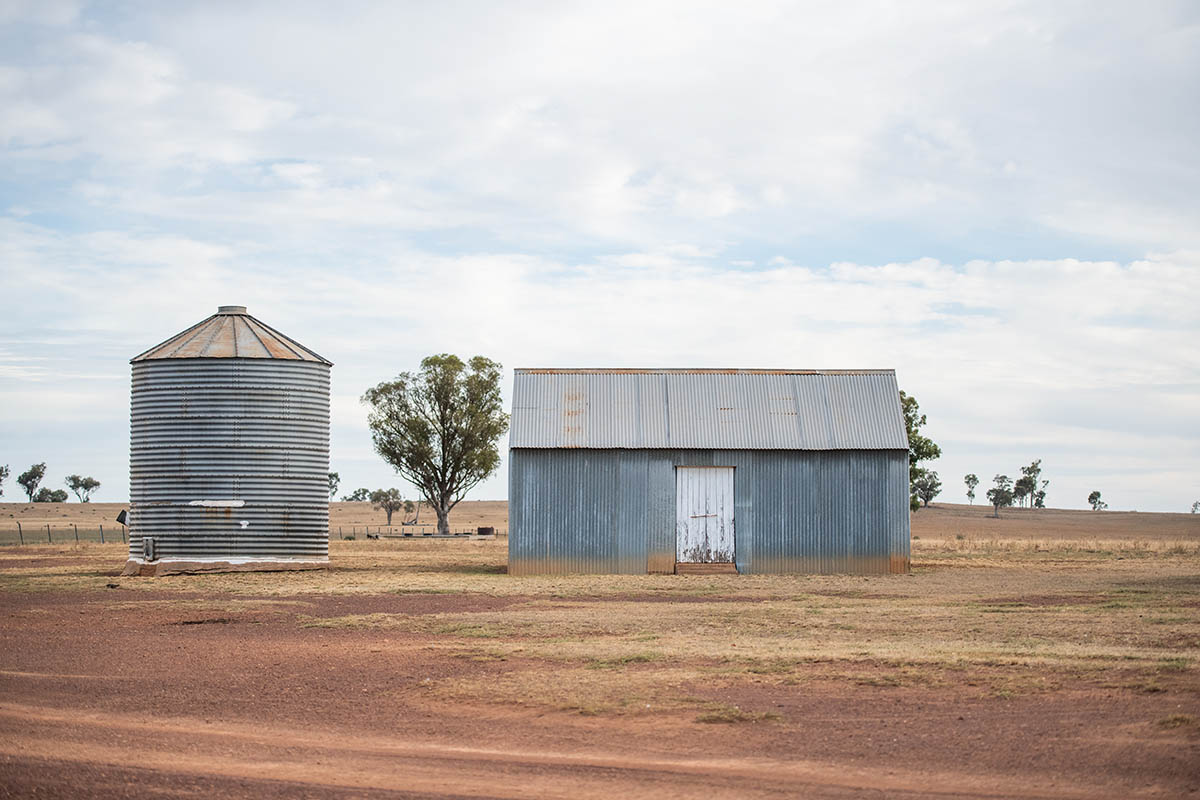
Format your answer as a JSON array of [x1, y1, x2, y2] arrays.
[[0, 0, 1200, 512]]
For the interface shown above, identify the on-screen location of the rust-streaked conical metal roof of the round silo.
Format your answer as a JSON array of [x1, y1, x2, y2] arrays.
[[132, 306, 332, 365]]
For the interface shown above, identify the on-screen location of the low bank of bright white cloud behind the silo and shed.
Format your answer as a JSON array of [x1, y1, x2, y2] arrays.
[[0, 215, 1200, 509]]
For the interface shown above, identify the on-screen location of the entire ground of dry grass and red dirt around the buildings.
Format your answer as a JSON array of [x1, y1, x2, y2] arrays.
[[0, 503, 1200, 798]]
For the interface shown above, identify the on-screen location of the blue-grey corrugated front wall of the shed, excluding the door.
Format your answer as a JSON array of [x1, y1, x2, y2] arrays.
[[509, 449, 910, 575]]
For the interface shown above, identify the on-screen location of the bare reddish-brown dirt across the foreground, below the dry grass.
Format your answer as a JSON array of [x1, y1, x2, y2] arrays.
[[0, 588, 1200, 799]]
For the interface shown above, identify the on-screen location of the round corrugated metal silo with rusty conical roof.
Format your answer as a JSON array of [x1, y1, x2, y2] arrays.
[[125, 306, 332, 575]]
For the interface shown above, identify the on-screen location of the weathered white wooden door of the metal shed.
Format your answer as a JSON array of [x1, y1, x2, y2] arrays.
[[676, 467, 733, 564]]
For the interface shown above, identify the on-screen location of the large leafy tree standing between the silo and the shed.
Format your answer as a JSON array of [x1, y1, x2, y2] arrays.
[[362, 354, 509, 533]]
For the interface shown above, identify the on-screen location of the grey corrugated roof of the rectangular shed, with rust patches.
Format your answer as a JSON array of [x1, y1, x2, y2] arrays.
[[509, 368, 908, 450]]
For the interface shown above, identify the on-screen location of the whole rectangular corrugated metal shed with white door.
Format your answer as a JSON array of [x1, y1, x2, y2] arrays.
[[509, 369, 910, 575]]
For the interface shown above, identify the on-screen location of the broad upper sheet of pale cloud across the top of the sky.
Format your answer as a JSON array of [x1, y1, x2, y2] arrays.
[[0, 2, 1200, 250]]
